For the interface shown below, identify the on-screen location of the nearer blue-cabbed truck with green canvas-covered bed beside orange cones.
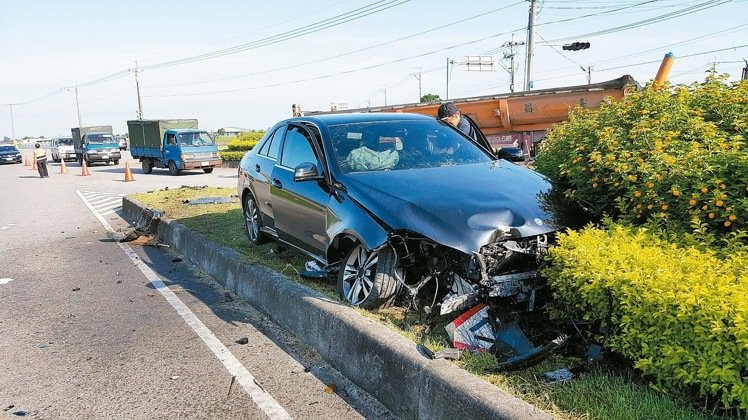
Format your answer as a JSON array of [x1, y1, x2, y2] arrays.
[[127, 119, 223, 175]]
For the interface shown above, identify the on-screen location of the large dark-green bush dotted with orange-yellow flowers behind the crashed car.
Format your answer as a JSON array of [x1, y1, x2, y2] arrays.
[[536, 75, 748, 234]]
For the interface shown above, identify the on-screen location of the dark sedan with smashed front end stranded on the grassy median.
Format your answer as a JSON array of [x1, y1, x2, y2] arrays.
[[237, 113, 558, 314]]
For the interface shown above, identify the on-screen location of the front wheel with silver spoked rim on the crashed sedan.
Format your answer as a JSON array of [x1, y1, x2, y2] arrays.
[[338, 243, 402, 309]]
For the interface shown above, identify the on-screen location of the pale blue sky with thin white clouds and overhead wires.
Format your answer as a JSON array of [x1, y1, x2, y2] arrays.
[[0, 0, 748, 138]]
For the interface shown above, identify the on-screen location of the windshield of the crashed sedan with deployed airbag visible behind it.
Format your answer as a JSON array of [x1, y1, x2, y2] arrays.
[[330, 120, 492, 173]]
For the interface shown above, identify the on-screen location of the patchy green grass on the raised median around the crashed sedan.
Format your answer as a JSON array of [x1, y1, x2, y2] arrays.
[[132, 187, 728, 420]]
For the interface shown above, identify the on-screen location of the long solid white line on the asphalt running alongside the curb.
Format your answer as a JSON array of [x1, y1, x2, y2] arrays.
[[76, 191, 291, 420]]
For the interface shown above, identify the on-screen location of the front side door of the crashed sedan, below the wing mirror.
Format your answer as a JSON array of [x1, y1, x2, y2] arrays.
[[270, 124, 330, 261]]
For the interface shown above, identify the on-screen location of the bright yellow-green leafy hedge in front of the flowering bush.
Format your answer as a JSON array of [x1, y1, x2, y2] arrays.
[[543, 225, 748, 410]]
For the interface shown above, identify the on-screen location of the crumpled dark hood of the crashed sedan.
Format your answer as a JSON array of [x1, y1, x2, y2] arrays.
[[344, 161, 558, 253]]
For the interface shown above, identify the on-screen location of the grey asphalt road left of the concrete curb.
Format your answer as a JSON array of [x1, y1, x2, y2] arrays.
[[0, 151, 393, 419]]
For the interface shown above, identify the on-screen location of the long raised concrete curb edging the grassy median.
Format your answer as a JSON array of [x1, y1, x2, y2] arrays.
[[122, 197, 552, 419]]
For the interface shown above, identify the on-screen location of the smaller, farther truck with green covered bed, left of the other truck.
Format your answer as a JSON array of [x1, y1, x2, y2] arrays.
[[70, 125, 122, 166]]
